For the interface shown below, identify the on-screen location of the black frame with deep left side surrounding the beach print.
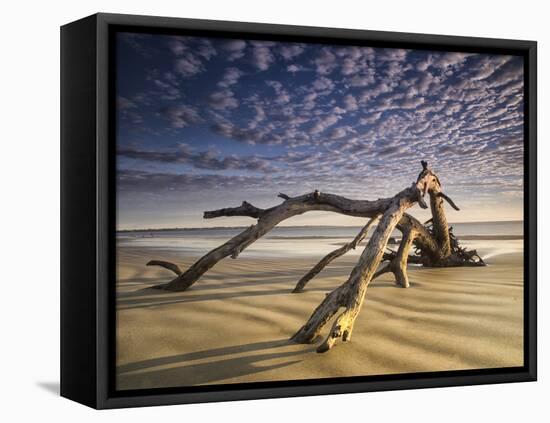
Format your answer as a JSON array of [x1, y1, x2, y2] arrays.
[[61, 13, 537, 409]]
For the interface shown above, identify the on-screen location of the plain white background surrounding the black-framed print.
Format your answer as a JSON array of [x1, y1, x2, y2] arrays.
[[0, 0, 550, 423]]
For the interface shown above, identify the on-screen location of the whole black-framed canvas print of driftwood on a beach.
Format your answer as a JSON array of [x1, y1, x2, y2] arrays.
[[61, 14, 536, 408]]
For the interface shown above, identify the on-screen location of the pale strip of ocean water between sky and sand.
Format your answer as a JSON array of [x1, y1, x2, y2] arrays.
[[117, 221, 523, 259]]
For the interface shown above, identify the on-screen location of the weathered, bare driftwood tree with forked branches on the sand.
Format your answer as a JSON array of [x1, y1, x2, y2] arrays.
[[148, 161, 484, 352]]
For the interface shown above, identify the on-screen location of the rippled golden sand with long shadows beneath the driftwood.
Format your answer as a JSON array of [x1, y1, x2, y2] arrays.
[[117, 247, 523, 389]]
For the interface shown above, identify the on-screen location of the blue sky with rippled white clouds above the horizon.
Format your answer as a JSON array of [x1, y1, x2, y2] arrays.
[[116, 33, 524, 229]]
